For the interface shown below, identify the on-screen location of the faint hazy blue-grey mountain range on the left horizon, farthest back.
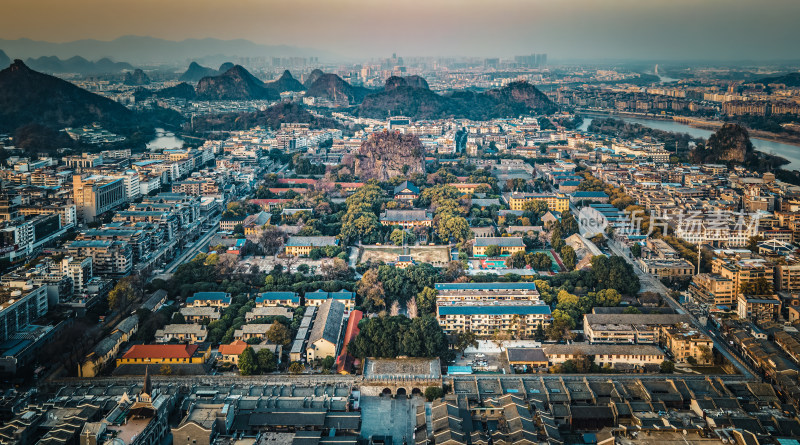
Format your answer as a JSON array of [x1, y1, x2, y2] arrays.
[[0, 36, 328, 65]]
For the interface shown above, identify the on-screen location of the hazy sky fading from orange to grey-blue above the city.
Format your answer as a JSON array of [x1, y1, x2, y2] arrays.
[[0, 0, 800, 60]]
